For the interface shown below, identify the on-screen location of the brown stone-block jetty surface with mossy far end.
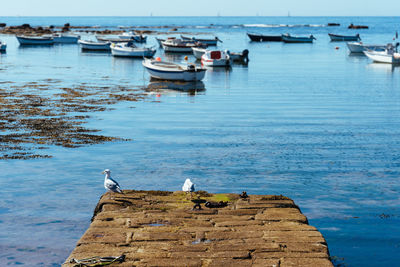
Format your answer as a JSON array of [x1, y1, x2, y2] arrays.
[[63, 190, 333, 267]]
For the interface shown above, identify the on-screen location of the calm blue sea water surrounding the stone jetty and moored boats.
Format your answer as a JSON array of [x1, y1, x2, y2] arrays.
[[0, 17, 400, 266]]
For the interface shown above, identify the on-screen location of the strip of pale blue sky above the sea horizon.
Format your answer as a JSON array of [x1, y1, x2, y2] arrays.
[[0, 0, 400, 16]]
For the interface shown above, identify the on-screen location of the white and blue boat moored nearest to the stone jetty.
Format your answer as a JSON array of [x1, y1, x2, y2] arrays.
[[142, 58, 206, 81]]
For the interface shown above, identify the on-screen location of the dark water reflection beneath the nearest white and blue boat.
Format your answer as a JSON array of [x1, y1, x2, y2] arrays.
[[145, 79, 206, 95]]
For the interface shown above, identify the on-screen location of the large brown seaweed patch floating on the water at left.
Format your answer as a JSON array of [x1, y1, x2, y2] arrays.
[[0, 79, 146, 160]]
